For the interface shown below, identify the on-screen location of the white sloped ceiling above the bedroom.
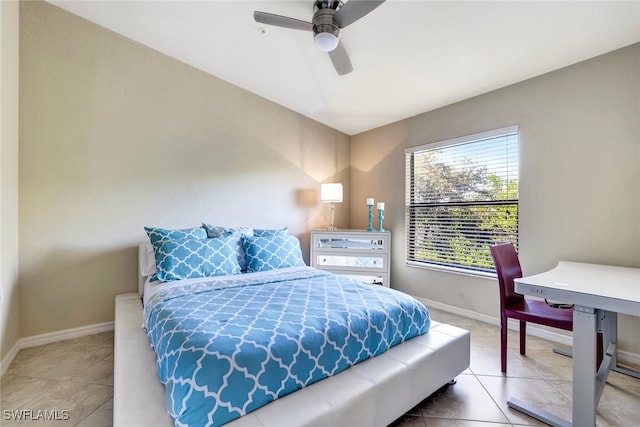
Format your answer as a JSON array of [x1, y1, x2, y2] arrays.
[[50, 0, 640, 135]]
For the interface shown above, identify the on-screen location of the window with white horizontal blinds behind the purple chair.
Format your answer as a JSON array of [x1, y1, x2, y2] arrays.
[[405, 126, 518, 271]]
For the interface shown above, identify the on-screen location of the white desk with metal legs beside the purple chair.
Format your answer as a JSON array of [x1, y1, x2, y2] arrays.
[[507, 261, 640, 427]]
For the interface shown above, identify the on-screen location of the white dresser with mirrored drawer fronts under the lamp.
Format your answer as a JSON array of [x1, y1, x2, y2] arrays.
[[311, 230, 391, 287]]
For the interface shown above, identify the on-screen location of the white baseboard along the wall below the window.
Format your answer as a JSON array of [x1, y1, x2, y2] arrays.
[[415, 297, 640, 366]]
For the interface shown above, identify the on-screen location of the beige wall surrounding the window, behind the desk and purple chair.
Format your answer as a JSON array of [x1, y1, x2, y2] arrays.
[[351, 44, 640, 353]]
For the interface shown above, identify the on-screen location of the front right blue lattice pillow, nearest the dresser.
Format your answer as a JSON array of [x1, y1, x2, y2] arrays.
[[242, 234, 306, 273]]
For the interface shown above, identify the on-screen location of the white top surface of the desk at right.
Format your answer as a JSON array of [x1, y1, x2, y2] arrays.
[[515, 261, 640, 316]]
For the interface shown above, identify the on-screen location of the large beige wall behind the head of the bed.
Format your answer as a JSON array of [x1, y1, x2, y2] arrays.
[[20, 2, 349, 337]]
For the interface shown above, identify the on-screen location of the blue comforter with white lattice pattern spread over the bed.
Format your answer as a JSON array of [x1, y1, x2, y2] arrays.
[[144, 267, 430, 426]]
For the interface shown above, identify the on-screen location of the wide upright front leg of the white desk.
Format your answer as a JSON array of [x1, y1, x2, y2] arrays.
[[572, 306, 597, 427]]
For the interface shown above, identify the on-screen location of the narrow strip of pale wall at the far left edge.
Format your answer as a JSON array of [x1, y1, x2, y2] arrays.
[[0, 1, 20, 360]]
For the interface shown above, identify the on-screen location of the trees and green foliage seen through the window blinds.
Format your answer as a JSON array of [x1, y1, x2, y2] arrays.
[[407, 152, 518, 270]]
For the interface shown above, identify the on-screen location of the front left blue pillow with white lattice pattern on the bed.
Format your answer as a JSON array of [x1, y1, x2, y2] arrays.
[[153, 236, 240, 282]]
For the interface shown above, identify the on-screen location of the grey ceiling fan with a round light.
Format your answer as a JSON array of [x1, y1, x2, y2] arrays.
[[253, 0, 385, 76]]
